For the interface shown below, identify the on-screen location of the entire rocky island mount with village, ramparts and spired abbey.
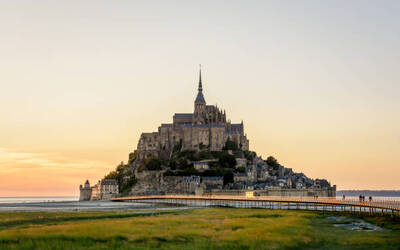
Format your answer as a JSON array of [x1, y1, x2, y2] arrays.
[[80, 67, 336, 200]]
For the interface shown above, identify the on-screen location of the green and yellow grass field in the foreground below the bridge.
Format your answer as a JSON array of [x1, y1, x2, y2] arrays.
[[0, 208, 400, 249]]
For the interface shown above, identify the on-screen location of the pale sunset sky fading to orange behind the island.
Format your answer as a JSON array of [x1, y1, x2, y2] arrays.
[[0, 0, 400, 196]]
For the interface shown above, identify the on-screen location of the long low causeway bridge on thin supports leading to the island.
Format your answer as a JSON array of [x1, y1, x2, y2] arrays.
[[111, 195, 400, 217]]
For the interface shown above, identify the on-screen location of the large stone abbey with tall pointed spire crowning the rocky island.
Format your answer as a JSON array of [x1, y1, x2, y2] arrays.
[[136, 70, 249, 160]]
